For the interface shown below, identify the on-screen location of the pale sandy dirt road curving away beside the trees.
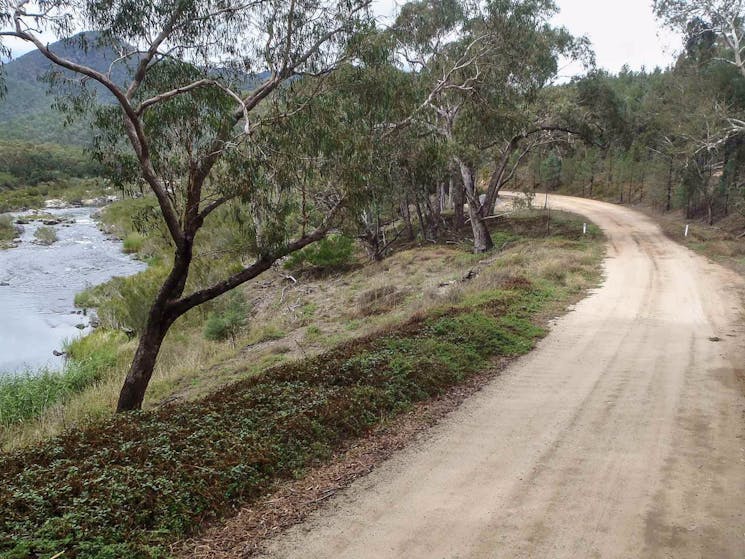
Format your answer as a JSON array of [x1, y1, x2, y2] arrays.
[[258, 197, 745, 559]]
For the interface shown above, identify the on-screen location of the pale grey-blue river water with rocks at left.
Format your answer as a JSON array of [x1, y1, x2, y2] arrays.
[[0, 208, 145, 375]]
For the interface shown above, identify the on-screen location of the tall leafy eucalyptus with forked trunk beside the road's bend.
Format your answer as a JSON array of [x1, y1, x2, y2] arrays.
[[394, 0, 585, 252]]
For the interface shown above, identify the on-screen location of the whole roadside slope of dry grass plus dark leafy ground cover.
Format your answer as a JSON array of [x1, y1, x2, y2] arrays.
[[0, 208, 602, 558]]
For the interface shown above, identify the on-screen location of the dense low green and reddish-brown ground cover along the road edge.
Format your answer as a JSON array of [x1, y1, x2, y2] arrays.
[[0, 282, 542, 559]]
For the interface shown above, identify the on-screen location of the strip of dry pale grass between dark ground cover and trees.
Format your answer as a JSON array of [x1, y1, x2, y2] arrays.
[[0, 210, 603, 450]]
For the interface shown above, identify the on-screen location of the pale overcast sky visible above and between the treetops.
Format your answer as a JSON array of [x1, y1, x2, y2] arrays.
[[6, 0, 680, 78]]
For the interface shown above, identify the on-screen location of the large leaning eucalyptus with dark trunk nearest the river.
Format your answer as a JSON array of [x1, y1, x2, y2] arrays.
[[0, 0, 370, 411]]
